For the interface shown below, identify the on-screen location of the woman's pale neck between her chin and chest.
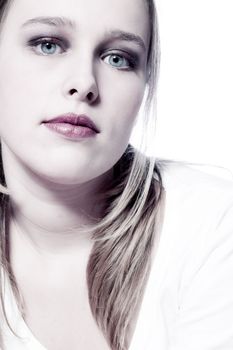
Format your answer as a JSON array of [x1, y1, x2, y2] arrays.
[[1, 147, 112, 255]]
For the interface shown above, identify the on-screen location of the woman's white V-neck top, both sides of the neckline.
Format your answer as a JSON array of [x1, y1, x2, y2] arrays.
[[1, 163, 233, 350]]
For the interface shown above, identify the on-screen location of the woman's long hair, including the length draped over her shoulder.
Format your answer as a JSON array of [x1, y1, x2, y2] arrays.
[[0, 0, 164, 350]]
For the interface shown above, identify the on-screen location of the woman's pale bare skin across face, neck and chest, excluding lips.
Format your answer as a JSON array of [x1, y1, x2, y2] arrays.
[[0, 0, 149, 350]]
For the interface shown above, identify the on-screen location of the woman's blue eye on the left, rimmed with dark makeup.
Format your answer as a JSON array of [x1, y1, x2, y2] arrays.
[[28, 38, 68, 56]]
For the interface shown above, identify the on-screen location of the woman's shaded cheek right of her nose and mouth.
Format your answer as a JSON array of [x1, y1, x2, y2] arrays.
[[95, 75, 145, 168]]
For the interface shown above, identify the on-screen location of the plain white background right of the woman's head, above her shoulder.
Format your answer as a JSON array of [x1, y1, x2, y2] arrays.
[[131, 0, 233, 179]]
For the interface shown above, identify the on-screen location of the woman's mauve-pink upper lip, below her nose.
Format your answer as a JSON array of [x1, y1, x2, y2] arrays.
[[44, 112, 100, 133]]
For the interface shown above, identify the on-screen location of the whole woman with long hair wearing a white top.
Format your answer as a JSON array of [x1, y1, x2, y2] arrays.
[[0, 0, 233, 350]]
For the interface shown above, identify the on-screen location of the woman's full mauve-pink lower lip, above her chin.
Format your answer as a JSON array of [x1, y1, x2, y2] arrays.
[[44, 122, 96, 139]]
